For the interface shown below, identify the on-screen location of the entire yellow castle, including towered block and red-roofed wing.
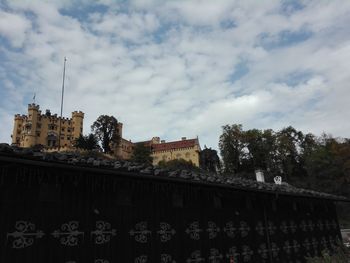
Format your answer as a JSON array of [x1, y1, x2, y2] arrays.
[[11, 103, 201, 166]]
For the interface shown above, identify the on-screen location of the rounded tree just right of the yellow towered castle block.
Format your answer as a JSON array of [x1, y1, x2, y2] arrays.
[[91, 115, 121, 153]]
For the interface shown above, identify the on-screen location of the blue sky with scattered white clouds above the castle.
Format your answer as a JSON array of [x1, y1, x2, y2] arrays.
[[0, 0, 350, 148]]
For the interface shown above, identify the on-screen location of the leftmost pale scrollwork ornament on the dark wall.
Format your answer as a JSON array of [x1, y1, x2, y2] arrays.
[[7, 221, 45, 249]]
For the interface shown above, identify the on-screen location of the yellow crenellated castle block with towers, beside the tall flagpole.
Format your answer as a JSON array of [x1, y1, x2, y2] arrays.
[[11, 103, 84, 148]]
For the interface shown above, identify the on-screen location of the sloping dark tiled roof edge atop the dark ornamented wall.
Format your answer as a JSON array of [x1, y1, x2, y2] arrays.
[[0, 143, 350, 202]]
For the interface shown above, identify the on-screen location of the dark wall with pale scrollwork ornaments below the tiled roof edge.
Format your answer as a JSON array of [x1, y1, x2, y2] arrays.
[[0, 158, 340, 263]]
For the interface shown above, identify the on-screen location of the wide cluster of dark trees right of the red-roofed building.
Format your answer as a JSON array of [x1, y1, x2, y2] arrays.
[[219, 124, 350, 199]]
